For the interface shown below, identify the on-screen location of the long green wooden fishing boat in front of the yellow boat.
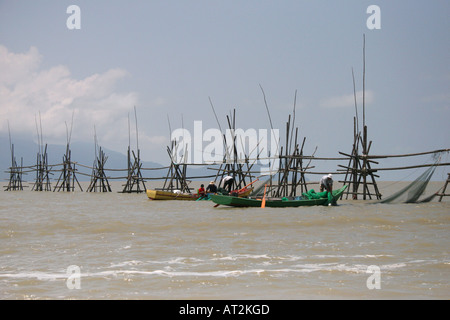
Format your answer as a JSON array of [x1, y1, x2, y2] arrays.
[[211, 186, 347, 208]]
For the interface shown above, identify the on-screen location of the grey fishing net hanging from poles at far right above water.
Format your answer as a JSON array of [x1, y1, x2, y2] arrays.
[[379, 160, 439, 203]]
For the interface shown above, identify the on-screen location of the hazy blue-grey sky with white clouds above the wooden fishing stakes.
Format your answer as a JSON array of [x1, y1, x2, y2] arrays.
[[0, 0, 450, 180]]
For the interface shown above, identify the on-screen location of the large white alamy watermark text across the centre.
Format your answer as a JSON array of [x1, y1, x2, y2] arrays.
[[171, 121, 280, 174]]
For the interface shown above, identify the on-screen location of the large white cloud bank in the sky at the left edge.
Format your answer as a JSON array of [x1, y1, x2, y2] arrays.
[[0, 45, 138, 149]]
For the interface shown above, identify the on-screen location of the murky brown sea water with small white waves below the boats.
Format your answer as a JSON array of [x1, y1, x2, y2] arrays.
[[0, 182, 450, 301]]
